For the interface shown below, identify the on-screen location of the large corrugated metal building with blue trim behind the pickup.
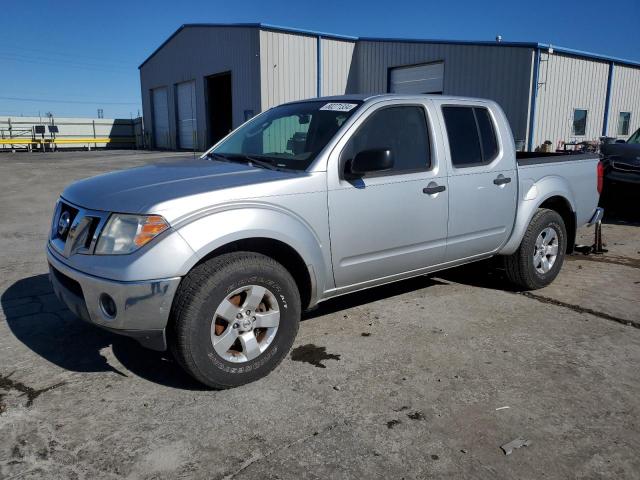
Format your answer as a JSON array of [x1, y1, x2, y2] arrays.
[[140, 24, 640, 150]]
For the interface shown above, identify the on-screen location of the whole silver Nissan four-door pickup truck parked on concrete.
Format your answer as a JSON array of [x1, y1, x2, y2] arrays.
[[47, 95, 602, 388]]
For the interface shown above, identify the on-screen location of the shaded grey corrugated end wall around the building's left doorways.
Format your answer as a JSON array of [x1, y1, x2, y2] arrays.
[[140, 26, 261, 150]]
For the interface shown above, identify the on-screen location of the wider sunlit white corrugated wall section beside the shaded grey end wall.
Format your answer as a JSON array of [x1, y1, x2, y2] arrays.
[[260, 30, 317, 110]]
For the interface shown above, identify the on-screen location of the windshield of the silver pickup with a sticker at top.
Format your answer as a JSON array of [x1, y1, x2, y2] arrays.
[[210, 101, 362, 170]]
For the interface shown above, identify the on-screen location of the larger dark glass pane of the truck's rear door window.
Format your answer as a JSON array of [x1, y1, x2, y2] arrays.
[[442, 107, 482, 168]]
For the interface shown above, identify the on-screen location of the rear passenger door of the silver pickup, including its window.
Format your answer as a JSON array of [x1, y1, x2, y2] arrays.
[[439, 102, 518, 261]]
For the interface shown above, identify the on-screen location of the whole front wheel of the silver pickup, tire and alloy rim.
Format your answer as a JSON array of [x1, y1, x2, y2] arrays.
[[169, 252, 301, 389]]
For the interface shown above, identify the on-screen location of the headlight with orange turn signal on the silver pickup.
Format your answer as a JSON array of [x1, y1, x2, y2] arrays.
[[95, 213, 169, 255]]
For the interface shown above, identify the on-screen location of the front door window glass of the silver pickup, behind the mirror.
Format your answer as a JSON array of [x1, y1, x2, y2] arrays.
[[343, 106, 431, 175]]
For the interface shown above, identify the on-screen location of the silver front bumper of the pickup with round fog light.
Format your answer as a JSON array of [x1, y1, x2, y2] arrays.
[[47, 247, 180, 350]]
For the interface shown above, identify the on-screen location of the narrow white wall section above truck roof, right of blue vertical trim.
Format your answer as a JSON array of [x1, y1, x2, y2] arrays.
[[321, 38, 356, 96]]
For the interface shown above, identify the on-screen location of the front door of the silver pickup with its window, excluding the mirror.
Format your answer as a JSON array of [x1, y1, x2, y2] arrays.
[[328, 104, 448, 288]]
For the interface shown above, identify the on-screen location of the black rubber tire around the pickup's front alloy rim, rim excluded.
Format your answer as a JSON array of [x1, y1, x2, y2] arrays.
[[169, 252, 301, 389]]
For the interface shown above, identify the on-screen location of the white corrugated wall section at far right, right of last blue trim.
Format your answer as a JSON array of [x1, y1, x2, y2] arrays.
[[607, 65, 640, 139]]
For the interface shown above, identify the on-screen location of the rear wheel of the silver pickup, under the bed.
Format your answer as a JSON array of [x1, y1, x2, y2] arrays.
[[505, 208, 567, 290]]
